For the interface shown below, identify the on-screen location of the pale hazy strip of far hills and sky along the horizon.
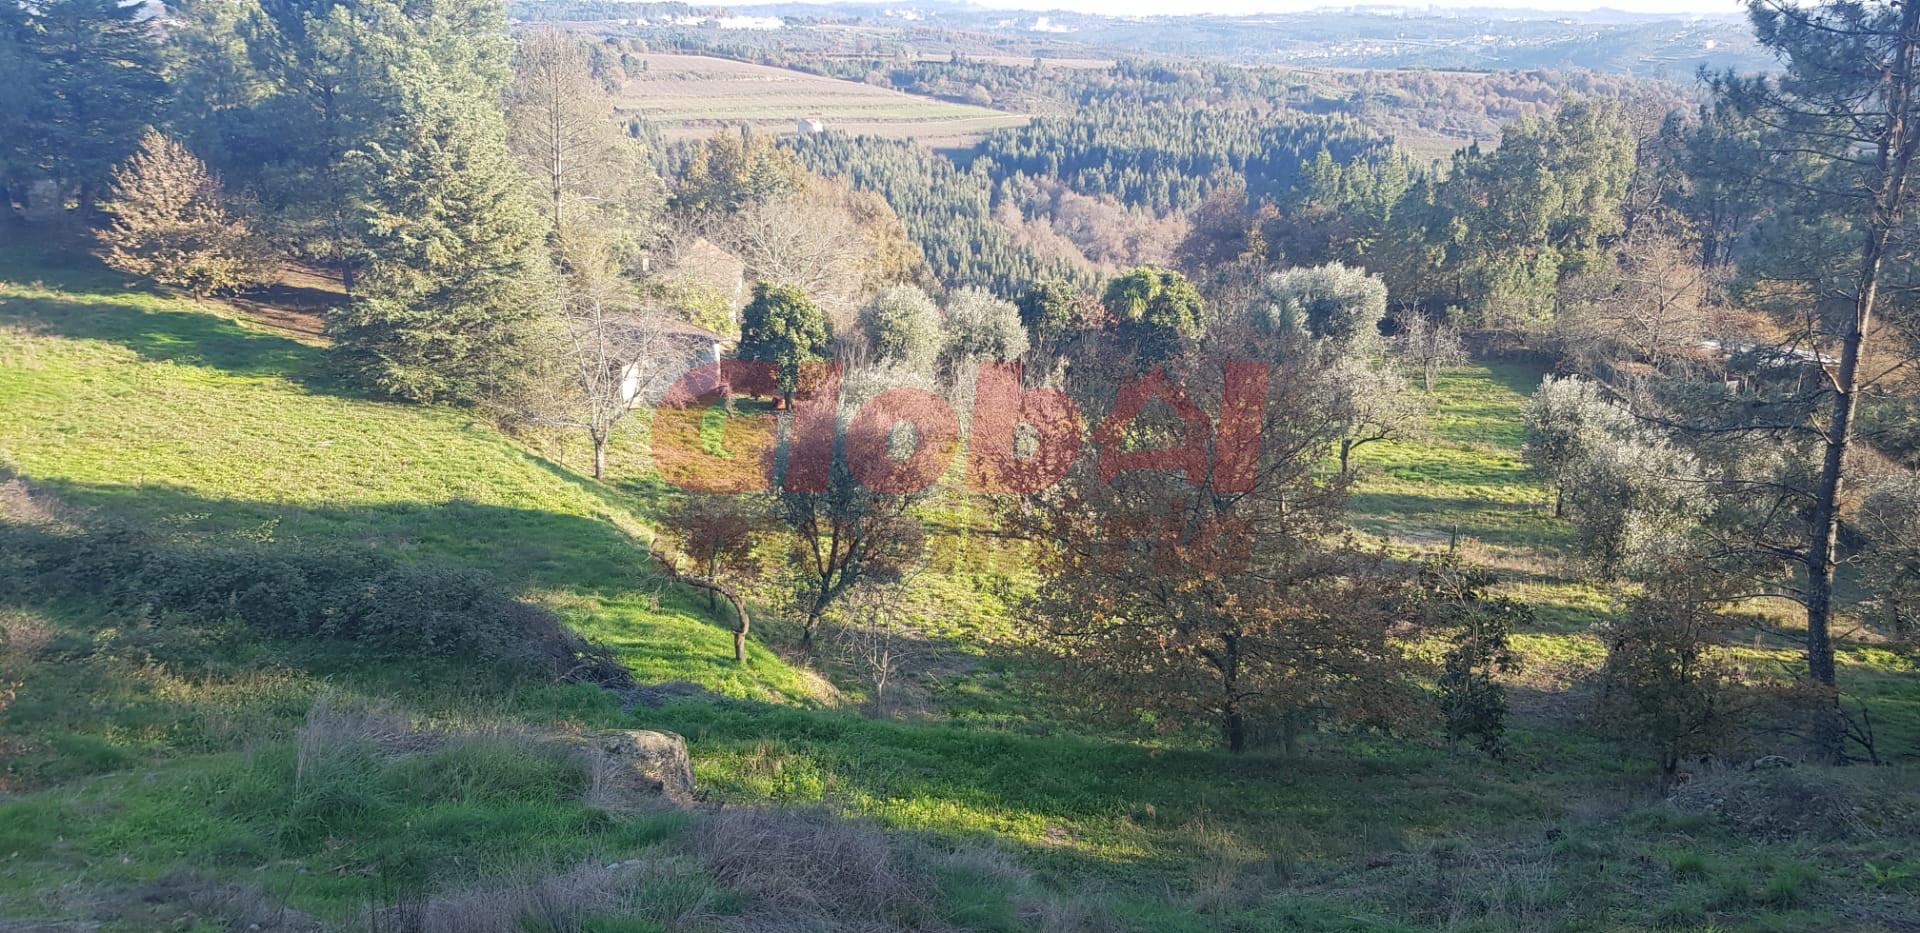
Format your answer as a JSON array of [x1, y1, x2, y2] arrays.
[[541, 0, 1772, 81]]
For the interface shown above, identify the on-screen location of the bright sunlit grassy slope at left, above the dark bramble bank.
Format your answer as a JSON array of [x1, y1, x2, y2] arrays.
[[0, 251, 812, 703]]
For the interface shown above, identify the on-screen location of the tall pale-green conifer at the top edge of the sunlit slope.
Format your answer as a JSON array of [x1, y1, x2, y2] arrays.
[[289, 0, 545, 403]]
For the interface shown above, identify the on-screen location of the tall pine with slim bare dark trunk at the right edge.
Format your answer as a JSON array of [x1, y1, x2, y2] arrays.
[[1680, 0, 1920, 760]]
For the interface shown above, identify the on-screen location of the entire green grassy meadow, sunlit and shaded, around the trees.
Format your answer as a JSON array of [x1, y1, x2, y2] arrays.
[[0, 246, 1920, 933]]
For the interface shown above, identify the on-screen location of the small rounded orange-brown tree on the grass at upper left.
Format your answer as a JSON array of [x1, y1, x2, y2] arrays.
[[96, 131, 267, 296]]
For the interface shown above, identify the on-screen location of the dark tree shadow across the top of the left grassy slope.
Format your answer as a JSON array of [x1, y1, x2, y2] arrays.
[[0, 248, 341, 397]]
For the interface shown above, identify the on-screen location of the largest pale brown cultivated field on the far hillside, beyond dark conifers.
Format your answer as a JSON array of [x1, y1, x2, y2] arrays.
[[618, 54, 1027, 144]]
